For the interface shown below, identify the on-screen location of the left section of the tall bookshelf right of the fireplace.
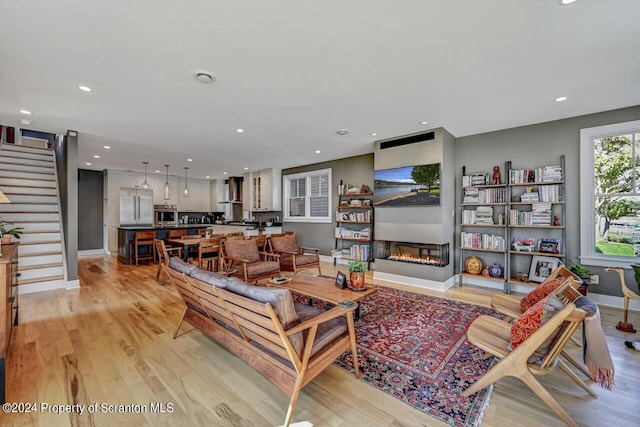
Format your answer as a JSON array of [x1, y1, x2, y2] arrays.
[[458, 164, 509, 287]]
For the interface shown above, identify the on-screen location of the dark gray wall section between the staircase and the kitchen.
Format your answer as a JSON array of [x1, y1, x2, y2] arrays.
[[78, 169, 104, 251]]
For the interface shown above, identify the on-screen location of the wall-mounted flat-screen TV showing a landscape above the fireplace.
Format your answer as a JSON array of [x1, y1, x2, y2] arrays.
[[373, 163, 440, 207]]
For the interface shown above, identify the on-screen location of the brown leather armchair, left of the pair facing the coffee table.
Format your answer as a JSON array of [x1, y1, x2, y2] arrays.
[[220, 239, 280, 283]]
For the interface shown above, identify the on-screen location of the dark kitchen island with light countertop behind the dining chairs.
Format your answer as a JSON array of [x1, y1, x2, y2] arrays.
[[118, 223, 282, 264]]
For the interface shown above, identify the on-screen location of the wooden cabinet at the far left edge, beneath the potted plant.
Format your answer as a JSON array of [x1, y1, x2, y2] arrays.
[[0, 244, 18, 403]]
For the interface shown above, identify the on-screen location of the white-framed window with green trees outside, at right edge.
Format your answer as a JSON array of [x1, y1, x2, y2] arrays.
[[580, 121, 640, 266]]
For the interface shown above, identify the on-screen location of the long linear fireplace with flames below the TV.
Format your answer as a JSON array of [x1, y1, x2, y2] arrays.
[[376, 240, 449, 267]]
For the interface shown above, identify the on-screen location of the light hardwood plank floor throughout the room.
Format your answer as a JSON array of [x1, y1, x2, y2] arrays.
[[0, 257, 640, 427]]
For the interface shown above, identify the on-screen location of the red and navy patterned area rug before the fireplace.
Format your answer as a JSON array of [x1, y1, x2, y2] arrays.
[[336, 285, 501, 426]]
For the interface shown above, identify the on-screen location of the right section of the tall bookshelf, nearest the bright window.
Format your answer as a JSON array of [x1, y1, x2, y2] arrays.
[[506, 155, 566, 292]]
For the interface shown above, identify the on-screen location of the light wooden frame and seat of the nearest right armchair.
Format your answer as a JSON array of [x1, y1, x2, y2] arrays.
[[462, 302, 592, 427]]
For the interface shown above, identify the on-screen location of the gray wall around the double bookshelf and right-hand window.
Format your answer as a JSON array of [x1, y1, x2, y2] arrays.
[[455, 106, 640, 296]]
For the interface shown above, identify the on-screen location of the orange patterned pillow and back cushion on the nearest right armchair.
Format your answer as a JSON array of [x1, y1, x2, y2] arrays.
[[511, 293, 564, 363]]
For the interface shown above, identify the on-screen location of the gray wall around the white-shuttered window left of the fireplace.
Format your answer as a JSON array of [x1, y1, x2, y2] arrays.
[[282, 154, 375, 255]]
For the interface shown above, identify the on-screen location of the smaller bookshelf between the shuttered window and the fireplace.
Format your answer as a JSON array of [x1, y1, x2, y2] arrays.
[[332, 191, 373, 268]]
